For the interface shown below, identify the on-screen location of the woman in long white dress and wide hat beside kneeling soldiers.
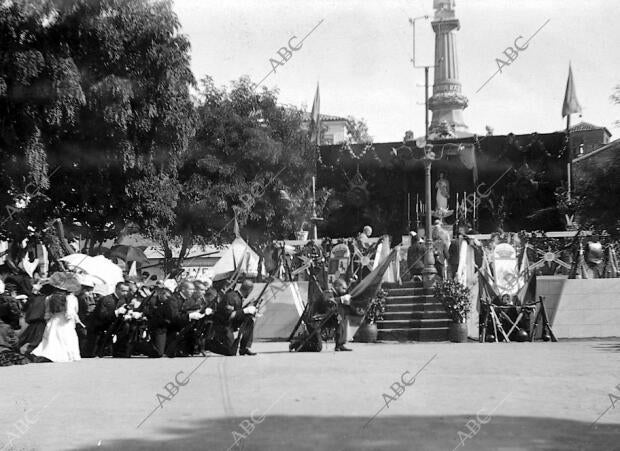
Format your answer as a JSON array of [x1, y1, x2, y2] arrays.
[[32, 273, 82, 362]]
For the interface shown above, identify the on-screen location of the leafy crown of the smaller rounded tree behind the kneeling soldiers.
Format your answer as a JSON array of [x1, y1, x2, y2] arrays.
[[188, 77, 315, 247]]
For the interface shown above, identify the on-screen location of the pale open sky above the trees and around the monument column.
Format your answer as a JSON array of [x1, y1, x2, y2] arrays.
[[174, 0, 620, 141]]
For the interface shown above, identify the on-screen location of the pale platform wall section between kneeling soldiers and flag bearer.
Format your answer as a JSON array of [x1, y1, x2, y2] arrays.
[[246, 279, 308, 340]]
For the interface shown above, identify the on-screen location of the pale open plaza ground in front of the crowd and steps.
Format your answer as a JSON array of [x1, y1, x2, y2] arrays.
[[0, 339, 620, 451]]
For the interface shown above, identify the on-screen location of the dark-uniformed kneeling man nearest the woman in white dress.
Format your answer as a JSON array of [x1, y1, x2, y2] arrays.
[[82, 282, 129, 357]]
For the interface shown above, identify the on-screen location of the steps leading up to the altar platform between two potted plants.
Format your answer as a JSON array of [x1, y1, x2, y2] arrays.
[[377, 282, 451, 341]]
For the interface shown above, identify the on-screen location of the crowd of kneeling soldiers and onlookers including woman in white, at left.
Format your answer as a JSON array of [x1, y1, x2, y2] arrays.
[[0, 272, 266, 366]]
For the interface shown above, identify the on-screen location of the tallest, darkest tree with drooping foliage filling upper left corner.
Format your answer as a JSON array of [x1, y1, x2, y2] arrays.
[[0, 0, 194, 258]]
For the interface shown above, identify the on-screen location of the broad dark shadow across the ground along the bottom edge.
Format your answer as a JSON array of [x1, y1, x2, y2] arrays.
[[78, 412, 620, 451]]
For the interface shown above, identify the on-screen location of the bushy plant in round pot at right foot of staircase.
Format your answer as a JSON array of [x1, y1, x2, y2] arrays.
[[435, 280, 471, 343]]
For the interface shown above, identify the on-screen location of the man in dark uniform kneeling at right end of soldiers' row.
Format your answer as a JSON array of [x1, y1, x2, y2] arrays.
[[208, 280, 256, 356]]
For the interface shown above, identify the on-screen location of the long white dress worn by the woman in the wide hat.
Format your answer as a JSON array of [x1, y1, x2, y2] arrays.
[[32, 294, 81, 362]]
